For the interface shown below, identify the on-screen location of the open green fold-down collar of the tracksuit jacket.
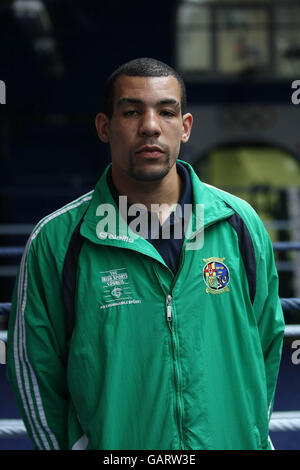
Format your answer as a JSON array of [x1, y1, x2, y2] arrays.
[[80, 160, 233, 263]]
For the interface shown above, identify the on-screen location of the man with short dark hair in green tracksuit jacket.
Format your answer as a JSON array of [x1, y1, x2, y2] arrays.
[[8, 59, 284, 450]]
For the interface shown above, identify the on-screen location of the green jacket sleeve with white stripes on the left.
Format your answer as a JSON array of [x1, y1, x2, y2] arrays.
[[7, 235, 68, 450]]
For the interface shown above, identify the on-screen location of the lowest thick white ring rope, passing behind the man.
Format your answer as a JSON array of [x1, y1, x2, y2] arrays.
[[0, 411, 300, 438]]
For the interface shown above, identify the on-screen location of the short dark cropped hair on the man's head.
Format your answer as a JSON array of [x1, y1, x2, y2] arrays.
[[103, 57, 187, 118]]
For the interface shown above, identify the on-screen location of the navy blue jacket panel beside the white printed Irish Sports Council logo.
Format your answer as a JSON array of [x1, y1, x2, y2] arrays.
[[62, 213, 85, 339]]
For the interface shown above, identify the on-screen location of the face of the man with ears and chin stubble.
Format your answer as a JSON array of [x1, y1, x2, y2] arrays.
[[96, 75, 192, 181]]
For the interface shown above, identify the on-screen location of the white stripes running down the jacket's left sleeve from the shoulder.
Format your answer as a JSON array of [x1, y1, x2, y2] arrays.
[[14, 191, 93, 449]]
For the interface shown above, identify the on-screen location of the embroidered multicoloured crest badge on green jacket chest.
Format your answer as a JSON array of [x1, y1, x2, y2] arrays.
[[203, 257, 230, 294]]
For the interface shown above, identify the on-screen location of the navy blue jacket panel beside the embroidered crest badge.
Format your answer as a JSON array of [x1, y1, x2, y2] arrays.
[[226, 203, 256, 304]]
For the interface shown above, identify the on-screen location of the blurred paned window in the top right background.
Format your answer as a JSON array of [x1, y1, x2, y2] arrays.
[[176, 0, 300, 78]]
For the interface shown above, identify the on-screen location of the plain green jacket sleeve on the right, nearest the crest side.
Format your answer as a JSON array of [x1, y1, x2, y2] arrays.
[[254, 229, 285, 420]]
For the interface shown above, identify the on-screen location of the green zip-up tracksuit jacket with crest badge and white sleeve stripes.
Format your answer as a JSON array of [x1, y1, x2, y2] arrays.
[[7, 162, 284, 450]]
